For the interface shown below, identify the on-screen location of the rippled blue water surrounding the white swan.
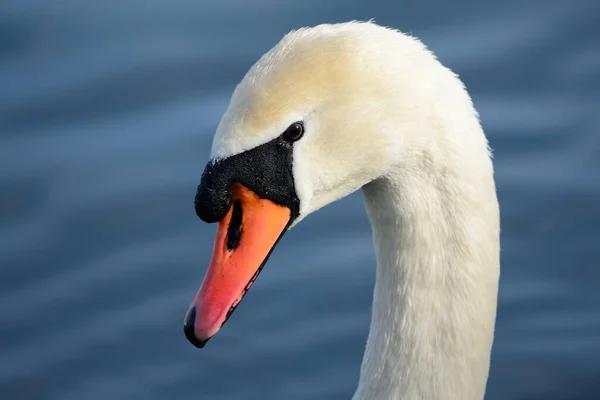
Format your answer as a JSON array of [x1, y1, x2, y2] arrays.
[[0, 0, 600, 400]]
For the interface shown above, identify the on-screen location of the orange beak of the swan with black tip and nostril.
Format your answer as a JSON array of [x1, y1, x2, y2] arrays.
[[184, 183, 291, 348]]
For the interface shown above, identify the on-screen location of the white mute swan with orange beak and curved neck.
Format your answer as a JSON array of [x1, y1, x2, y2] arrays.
[[184, 21, 500, 400]]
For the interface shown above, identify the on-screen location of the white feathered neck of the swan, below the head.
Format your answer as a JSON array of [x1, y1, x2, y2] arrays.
[[354, 162, 499, 400]]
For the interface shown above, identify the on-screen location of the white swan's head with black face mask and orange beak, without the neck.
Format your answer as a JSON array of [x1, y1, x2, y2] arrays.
[[184, 22, 482, 347]]
